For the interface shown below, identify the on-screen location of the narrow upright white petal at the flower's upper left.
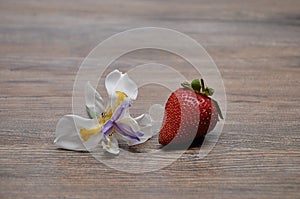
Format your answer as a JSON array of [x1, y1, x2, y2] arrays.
[[85, 82, 105, 114]]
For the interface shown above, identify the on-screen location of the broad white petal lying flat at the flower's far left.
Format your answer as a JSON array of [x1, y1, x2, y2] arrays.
[[54, 115, 101, 151]]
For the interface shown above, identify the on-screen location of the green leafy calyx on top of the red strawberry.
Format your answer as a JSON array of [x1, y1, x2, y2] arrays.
[[181, 79, 224, 119]]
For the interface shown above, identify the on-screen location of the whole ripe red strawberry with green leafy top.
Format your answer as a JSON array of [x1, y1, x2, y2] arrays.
[[159, 79, 223, 145]]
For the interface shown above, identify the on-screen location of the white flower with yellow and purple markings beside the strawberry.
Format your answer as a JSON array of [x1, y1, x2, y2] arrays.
[[54, 70, 157, 154]]
